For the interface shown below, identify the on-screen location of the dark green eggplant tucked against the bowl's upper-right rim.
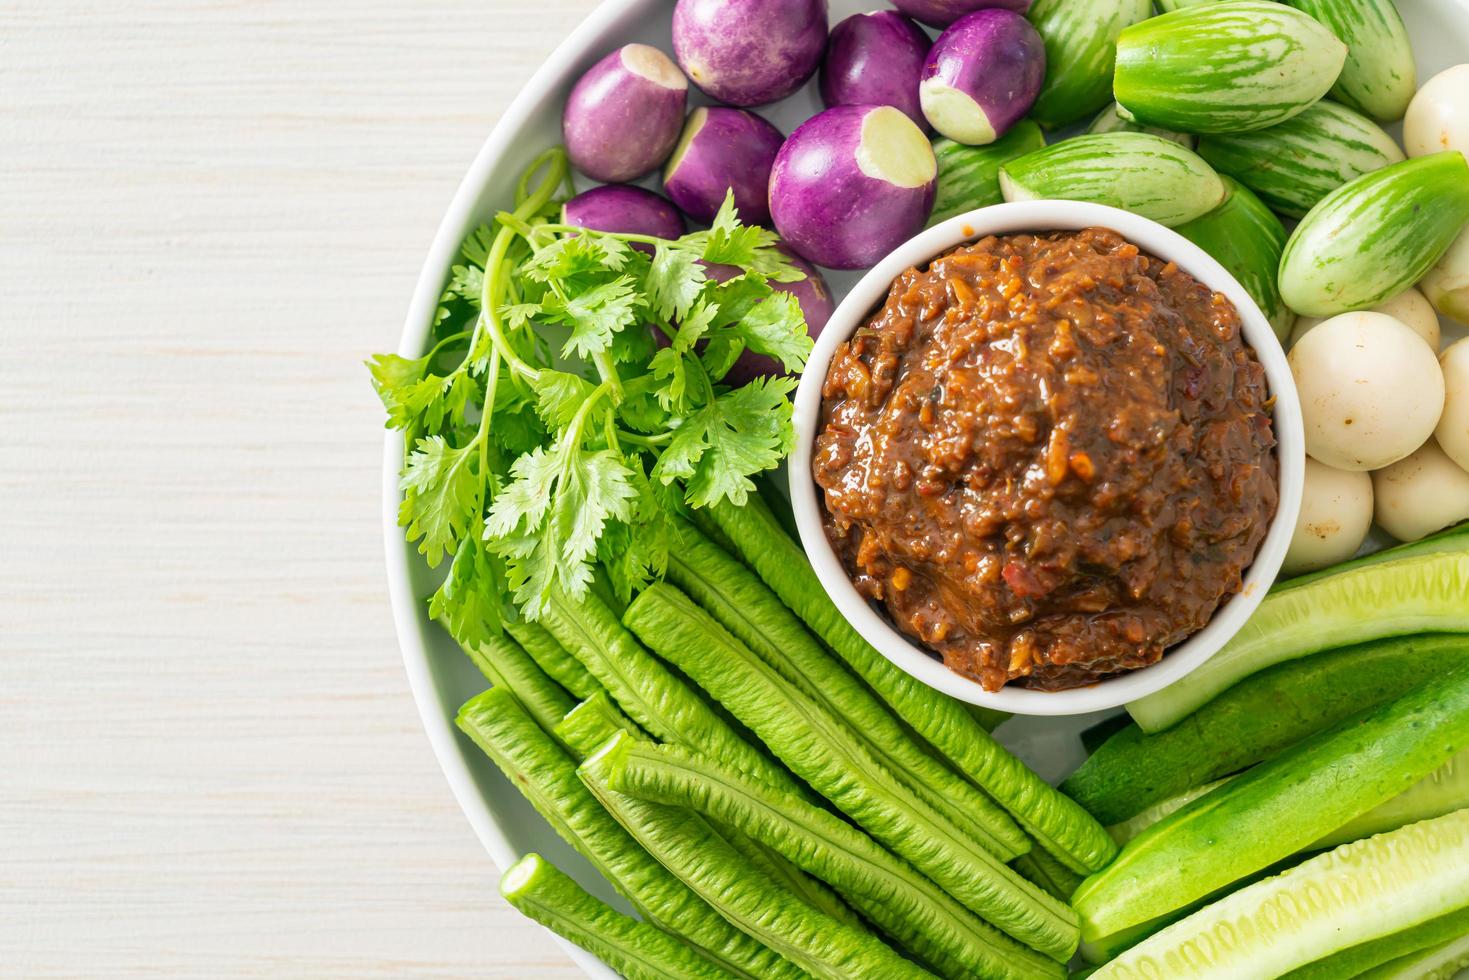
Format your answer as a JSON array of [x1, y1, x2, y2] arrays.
[[1175, 176, 1296, 344]]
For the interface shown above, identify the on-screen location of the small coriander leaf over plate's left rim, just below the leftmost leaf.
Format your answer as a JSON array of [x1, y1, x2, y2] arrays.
[[398, 435, 483, 569]]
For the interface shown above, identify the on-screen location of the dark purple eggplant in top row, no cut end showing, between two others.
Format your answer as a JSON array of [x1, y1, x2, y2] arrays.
[[820, 10, 933, 126]]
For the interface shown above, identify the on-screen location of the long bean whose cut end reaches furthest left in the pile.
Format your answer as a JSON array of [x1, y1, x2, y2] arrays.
[[457, 688, 801, 980]]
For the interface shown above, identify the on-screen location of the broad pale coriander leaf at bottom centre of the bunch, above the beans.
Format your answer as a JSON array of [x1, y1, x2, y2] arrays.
[[485, 439, 636, 619]]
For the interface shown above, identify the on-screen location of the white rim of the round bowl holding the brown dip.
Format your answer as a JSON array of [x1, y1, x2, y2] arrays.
[[789, 200, 1306, 716]]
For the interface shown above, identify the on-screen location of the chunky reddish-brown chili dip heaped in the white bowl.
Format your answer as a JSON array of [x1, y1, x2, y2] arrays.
[[812, 228, 1277, 691]]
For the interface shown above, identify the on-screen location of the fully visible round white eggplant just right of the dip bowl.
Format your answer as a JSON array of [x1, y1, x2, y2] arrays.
[[1288, 313, 1444, 470]]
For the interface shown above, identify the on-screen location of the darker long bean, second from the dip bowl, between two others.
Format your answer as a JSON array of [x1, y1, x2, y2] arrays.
[[668, 523, 1030, 858]]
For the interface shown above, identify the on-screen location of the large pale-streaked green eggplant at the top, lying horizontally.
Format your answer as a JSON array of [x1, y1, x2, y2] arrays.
[[1112, 0, 1347, 134]]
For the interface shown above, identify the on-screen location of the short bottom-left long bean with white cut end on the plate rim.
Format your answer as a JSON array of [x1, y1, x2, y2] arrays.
[[499, 854, 735, 980]]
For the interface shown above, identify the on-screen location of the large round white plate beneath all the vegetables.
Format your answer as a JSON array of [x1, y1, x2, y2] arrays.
[[382, 0, 1469, 980]]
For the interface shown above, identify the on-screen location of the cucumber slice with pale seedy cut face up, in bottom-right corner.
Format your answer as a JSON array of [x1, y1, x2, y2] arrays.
[[1094, 810, 1469, 980]]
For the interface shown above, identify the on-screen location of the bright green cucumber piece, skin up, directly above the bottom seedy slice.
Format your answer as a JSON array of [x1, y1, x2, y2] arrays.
[[1072, 667, 1469, 939]]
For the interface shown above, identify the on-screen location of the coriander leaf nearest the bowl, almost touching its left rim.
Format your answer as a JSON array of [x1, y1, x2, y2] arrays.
[[652, 378, 796, 507]]
